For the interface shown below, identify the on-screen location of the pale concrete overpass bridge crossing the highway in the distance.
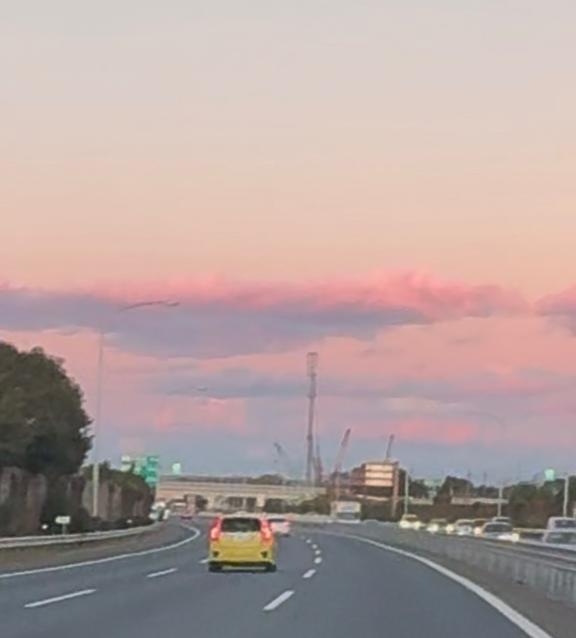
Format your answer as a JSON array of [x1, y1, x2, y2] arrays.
[[156, 475, 326, 510]]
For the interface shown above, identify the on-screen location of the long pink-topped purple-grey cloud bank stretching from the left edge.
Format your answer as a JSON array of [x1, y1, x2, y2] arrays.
[[0, 274, 527, 358]]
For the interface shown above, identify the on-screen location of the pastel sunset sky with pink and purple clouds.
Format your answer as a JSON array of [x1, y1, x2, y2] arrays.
[[0, 0, 576, 480]]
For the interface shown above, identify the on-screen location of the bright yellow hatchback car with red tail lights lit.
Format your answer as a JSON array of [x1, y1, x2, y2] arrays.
[[208, 514, 276, 572]]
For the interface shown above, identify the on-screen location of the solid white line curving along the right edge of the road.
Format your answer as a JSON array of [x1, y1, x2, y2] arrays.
[[339, 534, 553, 638]]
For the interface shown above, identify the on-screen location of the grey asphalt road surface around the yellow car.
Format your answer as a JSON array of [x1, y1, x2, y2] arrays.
[[0, 530, 546, 638]]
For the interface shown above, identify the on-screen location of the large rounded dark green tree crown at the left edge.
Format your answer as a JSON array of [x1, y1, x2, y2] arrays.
[[0, 342, 90, 478]]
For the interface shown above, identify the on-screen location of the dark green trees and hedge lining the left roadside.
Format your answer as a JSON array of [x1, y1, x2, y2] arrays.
[[0, 341, 152, 535]]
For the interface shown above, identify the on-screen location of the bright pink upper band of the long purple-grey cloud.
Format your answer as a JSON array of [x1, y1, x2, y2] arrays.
[[89, 273, 528, 321]]
